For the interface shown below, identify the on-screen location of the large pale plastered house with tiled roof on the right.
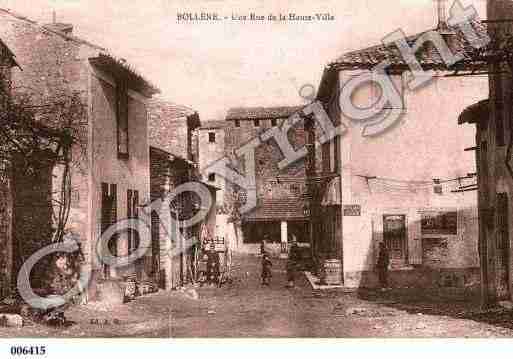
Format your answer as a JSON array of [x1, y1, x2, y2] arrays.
[[316, 7, 488, 288]]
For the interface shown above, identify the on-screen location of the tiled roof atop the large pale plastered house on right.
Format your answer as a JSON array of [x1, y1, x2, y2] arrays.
[[331, 22, 487, 68]]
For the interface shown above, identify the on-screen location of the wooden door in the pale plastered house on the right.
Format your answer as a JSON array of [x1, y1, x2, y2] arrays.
[[383, 214, 408, 265]]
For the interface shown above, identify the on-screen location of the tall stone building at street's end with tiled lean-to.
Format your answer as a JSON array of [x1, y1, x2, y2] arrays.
[[224, 106, 309, 254]]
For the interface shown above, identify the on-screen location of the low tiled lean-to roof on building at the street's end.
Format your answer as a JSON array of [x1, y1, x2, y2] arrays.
[[242, 198, 306, 222]]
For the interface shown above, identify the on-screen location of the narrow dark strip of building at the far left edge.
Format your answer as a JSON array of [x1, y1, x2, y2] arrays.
[[0, 39, 17, 298]]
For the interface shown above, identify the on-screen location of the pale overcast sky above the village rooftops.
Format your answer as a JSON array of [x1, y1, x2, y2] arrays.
[[0, 0, 486, 120]]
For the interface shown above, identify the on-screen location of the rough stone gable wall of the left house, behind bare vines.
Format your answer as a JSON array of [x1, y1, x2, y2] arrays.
[[0, 11, 94, 290]]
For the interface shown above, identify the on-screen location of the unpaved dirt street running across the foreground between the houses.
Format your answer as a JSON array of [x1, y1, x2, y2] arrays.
[[0, 256, 513, 338]]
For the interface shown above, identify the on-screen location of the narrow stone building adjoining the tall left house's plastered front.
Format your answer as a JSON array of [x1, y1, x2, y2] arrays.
[[149, 98, 217, 289]]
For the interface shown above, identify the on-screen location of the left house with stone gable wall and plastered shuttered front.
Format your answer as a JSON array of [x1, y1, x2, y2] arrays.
[[0, 10, 154, 296]]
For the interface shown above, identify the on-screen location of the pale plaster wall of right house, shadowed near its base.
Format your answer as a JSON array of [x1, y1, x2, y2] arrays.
[[331, 72, 488, 286]]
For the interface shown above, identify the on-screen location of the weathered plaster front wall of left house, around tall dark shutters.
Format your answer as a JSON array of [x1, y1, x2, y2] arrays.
[[90, 73, 151, 276]]
